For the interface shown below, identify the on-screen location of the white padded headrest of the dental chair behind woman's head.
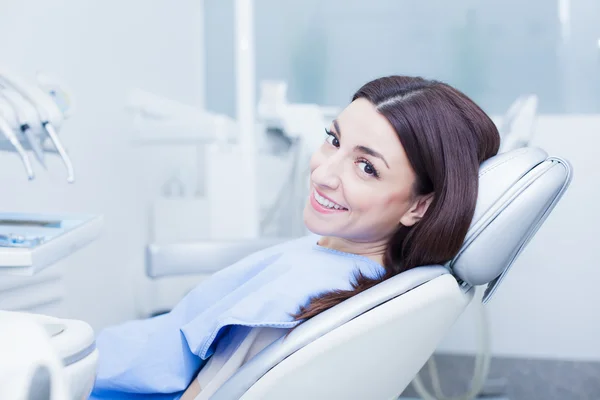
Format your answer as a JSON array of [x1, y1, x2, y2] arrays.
[[449, 147, 572, 302]]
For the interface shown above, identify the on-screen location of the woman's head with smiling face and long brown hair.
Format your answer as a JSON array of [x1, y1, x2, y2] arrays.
[[296, 76, 500, 320]]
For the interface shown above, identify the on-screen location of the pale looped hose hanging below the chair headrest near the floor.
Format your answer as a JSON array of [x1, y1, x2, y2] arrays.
[[412, 288, 491, 400]]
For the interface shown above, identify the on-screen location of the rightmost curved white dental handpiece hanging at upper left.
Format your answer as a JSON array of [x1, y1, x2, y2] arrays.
[[0, 70, 75, 183]]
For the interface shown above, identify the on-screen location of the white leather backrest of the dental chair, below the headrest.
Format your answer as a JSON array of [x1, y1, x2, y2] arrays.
[[216, 274, 473, 400]]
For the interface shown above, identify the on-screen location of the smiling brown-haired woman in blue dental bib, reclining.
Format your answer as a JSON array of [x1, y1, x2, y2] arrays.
[[92, 76, 500, 399]]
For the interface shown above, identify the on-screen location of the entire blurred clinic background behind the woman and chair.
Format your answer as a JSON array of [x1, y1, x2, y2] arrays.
[[0, 0, 600, 399]]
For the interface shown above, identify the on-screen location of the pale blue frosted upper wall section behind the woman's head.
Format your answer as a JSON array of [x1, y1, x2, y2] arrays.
[[205, 0, 600, 116]]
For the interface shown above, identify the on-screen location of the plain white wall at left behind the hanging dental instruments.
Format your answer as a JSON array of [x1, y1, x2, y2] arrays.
[[0, 0, 204, 328]]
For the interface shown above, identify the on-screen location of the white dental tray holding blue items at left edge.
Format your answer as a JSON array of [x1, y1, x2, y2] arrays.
[[0, 213, 103, 275]]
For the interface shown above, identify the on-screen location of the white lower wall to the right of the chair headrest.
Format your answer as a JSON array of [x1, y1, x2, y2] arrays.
[[440, 115, 600, 361]]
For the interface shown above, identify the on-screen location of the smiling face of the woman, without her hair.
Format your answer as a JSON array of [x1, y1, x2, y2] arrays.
[[304, 99, 431, 242]]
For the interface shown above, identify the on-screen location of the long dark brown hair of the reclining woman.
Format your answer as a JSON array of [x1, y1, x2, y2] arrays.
[[294, 76, 500, 320]]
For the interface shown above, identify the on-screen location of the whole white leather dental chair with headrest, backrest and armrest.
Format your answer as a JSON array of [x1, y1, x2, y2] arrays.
[[143, 148, 572, 400]]
